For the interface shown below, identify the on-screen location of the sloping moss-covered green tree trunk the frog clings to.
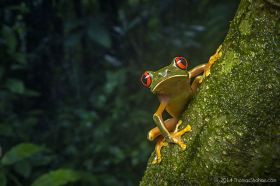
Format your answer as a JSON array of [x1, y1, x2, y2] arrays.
[[140, 0, 280, 185]]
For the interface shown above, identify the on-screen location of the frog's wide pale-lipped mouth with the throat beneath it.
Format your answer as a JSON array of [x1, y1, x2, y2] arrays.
[[152, 74, 188, 94]]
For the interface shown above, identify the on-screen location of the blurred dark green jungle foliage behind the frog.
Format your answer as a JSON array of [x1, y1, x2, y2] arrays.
[[0, 0, 238, 186]]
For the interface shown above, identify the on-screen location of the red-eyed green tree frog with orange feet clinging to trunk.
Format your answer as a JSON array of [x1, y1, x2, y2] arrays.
[[141, 45, 220, 164]]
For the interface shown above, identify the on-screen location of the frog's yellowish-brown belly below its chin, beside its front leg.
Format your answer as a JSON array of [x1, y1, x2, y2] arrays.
[[166, 92, 192, 119]]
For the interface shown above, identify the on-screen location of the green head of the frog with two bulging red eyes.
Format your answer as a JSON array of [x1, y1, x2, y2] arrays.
[[141, 57, 189, 94]]
